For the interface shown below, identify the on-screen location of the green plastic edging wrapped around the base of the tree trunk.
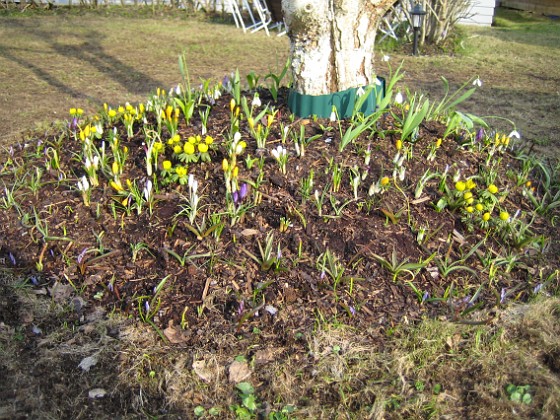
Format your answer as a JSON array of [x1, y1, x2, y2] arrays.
[[288, 77, 385, 119]]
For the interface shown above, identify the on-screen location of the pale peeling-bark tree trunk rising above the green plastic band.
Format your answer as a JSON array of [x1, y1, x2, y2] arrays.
[[282, 0, 397, 95]]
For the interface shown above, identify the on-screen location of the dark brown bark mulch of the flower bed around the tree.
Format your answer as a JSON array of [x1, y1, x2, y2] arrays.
[[0, 84, 560, 415]]
